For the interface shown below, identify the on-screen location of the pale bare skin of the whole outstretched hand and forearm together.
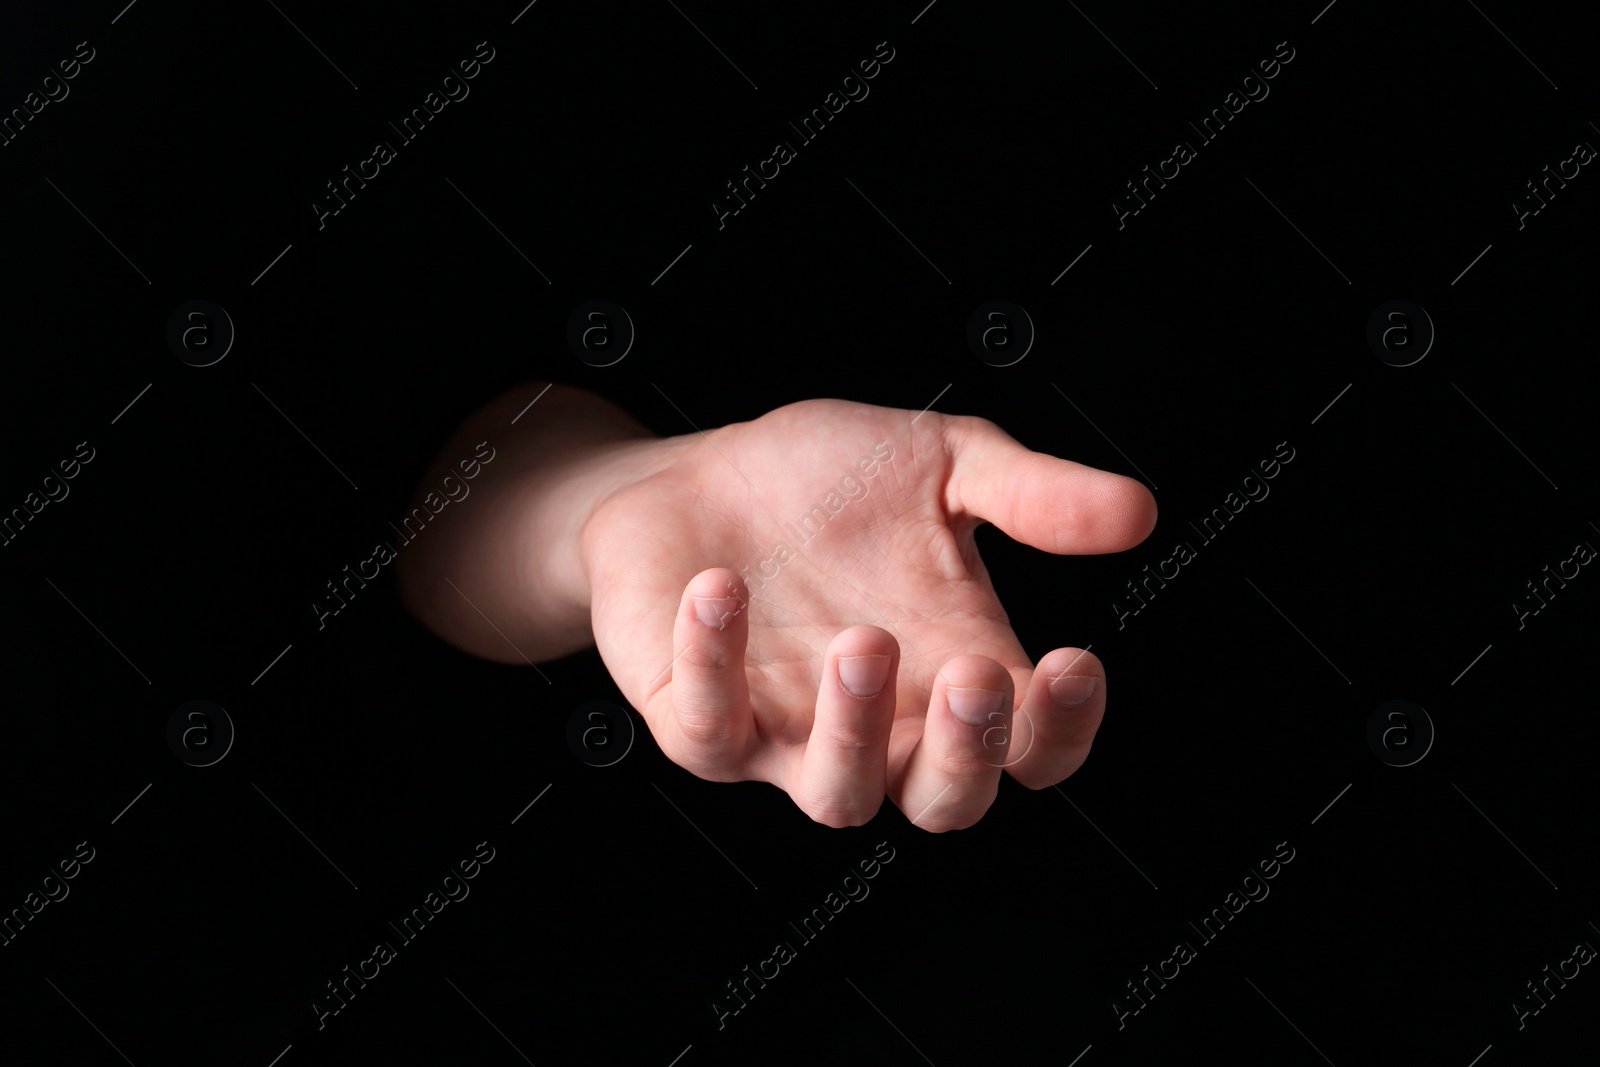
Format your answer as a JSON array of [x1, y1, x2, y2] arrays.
[[397, 382, 1155, 832]]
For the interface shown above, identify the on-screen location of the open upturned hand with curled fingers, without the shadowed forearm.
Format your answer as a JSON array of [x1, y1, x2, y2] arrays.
[[579, 400, 1155, 832]]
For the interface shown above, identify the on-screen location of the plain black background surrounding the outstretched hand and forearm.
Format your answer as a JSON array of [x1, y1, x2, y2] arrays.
[[0, 0, 1600, 1067]]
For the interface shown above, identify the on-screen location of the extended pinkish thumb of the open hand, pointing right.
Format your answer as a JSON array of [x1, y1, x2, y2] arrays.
[[944, 416, 1155, 555]]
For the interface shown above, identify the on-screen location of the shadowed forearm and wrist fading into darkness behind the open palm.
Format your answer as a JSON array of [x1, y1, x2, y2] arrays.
[[398, 381, 672, 664]]
